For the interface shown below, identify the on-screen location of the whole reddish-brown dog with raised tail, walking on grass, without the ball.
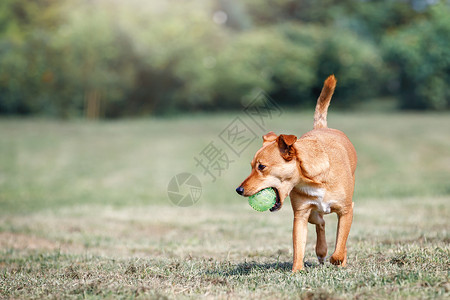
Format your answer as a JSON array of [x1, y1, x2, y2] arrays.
[[236, 75, 356, 271]]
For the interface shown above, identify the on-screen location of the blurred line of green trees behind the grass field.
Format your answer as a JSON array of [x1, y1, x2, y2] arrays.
[[0, 0, 450, 118]]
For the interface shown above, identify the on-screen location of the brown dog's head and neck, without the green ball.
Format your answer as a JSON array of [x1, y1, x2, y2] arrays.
[[236, 132, 329, 211]]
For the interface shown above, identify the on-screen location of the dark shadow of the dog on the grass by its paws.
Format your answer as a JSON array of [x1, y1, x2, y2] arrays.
[[211, 261, 320, 276]]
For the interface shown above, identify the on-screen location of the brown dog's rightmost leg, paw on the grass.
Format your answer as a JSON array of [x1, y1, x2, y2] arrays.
[[330, 203, 353, 267]]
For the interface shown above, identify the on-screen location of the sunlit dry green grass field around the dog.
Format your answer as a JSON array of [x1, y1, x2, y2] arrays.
[[0, 112, 450, 299]]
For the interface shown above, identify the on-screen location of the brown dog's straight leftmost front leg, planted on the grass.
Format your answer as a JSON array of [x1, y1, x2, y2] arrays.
[[292, 209, 311, 272]]
